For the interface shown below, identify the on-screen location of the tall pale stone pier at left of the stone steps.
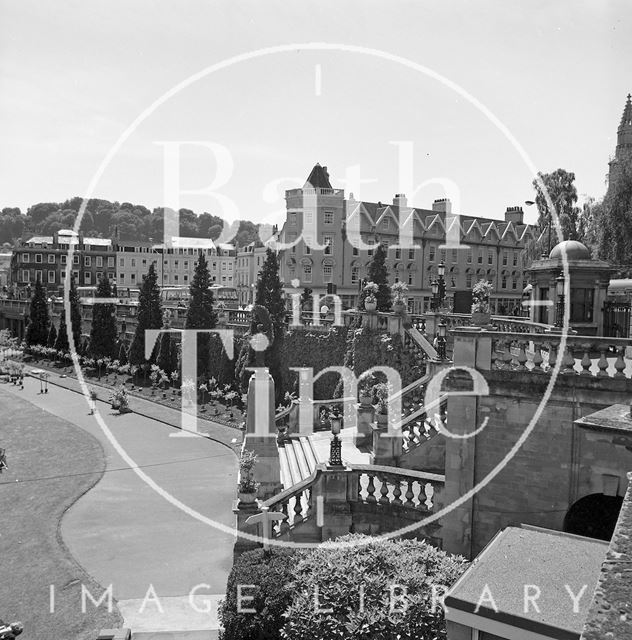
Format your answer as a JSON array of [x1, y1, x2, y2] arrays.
[[242, 367, 282, 500]]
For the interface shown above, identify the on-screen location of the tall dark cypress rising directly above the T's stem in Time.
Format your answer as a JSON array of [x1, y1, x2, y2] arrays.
[[184, 253, 217, 378]]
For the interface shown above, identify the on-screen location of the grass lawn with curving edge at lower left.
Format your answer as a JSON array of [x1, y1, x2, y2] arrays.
[[0, 384, 121, 640]]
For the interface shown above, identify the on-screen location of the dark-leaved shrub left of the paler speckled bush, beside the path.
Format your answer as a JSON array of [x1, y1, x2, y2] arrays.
[[219, 548, 299, 640]]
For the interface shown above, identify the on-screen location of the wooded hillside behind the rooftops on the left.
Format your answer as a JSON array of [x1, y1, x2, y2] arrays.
[[0, 197, 258, 246]]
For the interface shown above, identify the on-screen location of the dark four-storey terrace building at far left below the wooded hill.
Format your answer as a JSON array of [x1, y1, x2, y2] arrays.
[[11, 229, 116, 296]]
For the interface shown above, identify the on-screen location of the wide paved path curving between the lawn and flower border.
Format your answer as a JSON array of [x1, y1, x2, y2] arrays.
[[0, 378, 240, 638]]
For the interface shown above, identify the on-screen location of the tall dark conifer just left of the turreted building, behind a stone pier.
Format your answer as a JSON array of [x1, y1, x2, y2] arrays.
[[255, 249, 288, 404]]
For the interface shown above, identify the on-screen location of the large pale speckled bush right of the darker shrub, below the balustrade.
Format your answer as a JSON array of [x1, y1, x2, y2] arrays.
[[278, 535, 467, 640]]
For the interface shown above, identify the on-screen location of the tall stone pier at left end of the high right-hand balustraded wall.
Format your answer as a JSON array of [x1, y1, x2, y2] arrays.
[[442, 327, 491, 558]]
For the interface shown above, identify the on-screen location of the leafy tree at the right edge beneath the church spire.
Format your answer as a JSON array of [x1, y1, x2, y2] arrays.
[[599, 158, 632, 265]]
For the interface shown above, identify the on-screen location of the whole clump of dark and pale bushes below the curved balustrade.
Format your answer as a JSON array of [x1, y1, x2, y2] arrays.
[[220, 535, 467, 640]]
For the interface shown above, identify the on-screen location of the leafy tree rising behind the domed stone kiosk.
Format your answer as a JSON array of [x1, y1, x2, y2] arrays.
[[533, 169, 582, 249]]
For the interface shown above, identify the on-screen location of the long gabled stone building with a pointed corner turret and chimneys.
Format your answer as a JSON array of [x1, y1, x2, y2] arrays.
[[279, 164, 536, 314]]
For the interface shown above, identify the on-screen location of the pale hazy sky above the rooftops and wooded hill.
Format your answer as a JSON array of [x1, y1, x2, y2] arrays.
[[0, 0, 632, 228]]
